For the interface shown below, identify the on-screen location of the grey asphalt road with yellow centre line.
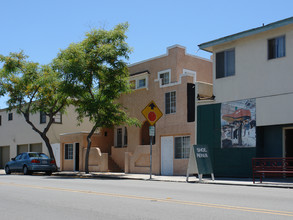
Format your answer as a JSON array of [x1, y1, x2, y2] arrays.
[[0, 175, 293, 220]]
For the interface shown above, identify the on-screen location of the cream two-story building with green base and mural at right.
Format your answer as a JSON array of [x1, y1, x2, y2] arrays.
[[198, 17, 293, 176]]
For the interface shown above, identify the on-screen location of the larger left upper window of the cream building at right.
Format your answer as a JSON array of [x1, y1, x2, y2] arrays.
[[216, 49, 235, 79]]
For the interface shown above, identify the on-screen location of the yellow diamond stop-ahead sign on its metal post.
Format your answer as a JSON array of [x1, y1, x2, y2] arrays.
[[141, 101, 163, 179]]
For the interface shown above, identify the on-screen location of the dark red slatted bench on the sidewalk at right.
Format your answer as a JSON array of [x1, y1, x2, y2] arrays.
[[252, 157, 293, 183]]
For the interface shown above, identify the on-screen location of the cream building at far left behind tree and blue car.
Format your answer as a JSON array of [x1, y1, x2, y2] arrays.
[[0, 107, 90, 168]]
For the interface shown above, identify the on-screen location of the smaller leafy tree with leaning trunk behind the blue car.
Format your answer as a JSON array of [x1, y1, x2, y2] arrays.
[[0, 51, 69, 162]]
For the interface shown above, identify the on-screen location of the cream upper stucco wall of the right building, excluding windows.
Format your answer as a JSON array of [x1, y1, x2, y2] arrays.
[[213, 24, 293, 126]]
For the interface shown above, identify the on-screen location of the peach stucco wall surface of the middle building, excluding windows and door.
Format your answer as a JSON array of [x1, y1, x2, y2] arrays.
[[112, 46, 212, 175]]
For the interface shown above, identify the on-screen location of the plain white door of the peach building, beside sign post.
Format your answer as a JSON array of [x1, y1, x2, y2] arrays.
[[161, 136, 173, 176]]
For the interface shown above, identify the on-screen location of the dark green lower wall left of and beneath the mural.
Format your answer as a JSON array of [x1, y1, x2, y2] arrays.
[[197, 104, 256, 177]]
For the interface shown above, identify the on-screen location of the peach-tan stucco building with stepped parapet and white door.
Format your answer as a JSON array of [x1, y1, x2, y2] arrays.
[[61, 45, 212, 175]]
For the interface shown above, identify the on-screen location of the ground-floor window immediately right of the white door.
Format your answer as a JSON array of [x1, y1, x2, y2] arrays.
[[175, 136, 190, 159]]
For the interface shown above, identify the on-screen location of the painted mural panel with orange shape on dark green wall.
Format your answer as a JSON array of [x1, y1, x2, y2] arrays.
[[221, 99, 256, 148]]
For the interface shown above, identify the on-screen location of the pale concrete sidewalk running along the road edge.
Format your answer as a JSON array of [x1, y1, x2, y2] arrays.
[[0, 169, 293, 189]]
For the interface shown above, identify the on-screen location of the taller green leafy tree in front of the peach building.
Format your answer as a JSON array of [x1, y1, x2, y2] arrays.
[[53, 23, 139, 173]]
